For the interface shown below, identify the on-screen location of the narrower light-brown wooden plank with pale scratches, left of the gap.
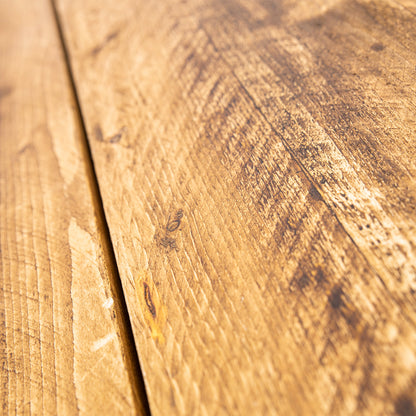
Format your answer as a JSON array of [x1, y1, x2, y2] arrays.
[[0, 0, 144, 415]]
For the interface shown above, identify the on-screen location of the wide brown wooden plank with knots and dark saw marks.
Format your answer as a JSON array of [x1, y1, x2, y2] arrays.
[[56, 0, 416, 415]]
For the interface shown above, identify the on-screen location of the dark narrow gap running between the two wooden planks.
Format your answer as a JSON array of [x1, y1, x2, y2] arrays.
[[51, 0, 151, 416]]
